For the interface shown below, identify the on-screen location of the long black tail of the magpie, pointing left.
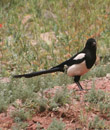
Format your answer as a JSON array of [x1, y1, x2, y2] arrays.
[[13, 67, 62, 78]]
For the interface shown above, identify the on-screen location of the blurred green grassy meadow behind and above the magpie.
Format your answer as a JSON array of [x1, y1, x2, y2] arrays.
[[0, 0, 110, 76]]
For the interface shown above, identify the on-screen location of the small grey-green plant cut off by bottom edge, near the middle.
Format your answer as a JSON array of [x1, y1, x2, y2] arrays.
[[47, 119, 65, 130]]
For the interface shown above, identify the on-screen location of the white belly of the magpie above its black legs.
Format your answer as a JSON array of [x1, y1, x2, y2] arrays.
[[67, 61, 89, 77]]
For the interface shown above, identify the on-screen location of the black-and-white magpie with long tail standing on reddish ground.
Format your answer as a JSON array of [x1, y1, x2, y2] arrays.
[[13, 38, 97, 91]]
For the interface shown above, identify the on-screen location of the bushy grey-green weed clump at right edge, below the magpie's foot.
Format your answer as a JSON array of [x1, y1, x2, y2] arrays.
[[85, 83, 110, 117]]
